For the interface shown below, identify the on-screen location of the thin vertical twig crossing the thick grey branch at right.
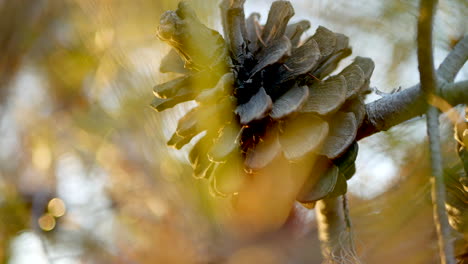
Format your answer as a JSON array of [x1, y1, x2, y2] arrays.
[[418, 0, 455, 264]]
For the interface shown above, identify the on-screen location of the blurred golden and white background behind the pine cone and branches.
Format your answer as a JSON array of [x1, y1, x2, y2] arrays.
[[0, 0, 468, 264]]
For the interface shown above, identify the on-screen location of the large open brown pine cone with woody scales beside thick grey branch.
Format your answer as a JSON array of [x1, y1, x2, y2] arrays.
[[151, 0, 374, 202]]
